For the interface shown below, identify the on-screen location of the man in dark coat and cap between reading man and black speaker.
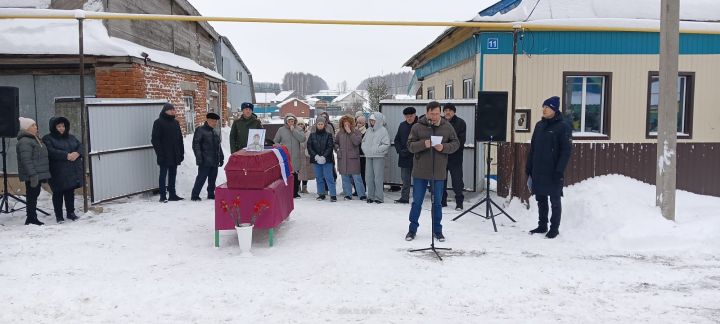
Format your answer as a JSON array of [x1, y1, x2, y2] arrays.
[[442, 103, 467, 211]]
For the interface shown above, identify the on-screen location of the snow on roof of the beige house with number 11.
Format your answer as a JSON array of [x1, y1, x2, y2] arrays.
[[472, 0, 720, 22]]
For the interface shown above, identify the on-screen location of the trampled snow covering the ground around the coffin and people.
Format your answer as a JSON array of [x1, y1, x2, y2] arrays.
[[0, 131, 720, 323]]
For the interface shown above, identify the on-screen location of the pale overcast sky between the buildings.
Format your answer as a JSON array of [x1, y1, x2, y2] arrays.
[[190, 0, 497, 89]]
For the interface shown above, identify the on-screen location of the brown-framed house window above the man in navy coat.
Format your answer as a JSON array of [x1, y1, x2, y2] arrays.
[[563, 72, 612, 139]]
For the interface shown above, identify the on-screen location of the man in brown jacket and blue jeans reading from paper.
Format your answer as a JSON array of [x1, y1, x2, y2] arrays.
[[405, 101, 460, 242]]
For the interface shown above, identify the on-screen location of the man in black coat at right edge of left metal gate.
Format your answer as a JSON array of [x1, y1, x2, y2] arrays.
[[151, 103, 185, 202]]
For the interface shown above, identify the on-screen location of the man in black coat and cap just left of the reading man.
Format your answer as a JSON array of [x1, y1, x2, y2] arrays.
[[394, 107, 417, 204]]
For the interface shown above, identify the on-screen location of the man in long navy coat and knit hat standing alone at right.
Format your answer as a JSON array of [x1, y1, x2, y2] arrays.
[[525, 97, 572, 238]]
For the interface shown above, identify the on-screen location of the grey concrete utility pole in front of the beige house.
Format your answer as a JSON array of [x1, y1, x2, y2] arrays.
[[655, 0, 680, 221]]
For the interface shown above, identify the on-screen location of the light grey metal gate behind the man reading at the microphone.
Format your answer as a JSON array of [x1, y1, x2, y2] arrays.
[[380, 100, 485, 191]]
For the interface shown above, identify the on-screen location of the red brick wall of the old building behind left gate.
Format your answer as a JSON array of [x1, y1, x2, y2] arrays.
[[95, 63, 228, 134]]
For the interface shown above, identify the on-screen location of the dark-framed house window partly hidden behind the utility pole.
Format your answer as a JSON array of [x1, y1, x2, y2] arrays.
[[646, 72, 695, 138]]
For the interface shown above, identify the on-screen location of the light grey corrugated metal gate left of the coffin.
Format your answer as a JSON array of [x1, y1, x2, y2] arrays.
[[88, 99, 164, 203]]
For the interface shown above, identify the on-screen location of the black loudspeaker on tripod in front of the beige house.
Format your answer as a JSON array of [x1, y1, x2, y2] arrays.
[[475, 91, 508, 142]]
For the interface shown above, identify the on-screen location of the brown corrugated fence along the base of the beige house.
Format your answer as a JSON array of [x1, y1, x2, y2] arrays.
[[498, 143, 720, 200]]
